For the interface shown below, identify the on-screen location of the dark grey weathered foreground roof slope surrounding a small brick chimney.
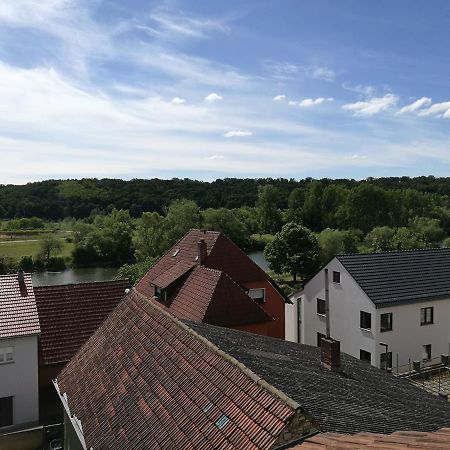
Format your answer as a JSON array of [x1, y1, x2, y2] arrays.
[[187, 322, 450, 434]]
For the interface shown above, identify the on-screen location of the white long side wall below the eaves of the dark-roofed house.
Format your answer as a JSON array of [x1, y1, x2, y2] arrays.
[[377, 299, 450, 369]]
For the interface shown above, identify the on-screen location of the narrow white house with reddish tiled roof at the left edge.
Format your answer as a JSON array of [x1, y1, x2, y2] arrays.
[[0, 272, 40, 434]]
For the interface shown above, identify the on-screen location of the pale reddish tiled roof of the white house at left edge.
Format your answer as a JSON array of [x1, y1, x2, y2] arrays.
[[0, 273, 40, 338]]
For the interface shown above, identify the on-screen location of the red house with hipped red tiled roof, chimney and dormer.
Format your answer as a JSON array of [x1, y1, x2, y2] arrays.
[[136, 230, 289, 339]]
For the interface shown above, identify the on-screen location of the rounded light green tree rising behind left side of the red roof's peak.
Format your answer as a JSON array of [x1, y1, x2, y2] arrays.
[[165, 199, 201, 247]]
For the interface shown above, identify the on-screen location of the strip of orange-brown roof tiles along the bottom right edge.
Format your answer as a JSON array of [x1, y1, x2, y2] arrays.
[[298, 428, 450, 450]]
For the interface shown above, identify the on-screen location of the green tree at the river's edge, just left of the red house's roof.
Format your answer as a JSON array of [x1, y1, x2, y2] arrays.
[[133, 212, 168, 262]]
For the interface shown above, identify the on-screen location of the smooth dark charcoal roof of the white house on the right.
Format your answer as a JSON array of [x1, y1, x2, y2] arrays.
[[337, 248, 450, 306]]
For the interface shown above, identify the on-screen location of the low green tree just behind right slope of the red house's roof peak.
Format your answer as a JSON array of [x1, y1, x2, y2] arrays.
[[202, 208, 250, 249]]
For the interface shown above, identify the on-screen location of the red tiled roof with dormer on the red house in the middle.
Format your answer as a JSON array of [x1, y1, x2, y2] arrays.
[[136, 230, 273, 326]]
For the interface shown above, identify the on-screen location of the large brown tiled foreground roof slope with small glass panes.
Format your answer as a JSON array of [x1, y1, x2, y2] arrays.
[[57, 290, 297, 450]]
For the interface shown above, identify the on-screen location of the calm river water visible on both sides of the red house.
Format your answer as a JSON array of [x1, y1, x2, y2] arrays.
[[33, 251, 269, 286]]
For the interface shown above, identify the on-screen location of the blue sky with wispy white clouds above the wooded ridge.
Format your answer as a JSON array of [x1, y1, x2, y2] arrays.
[[0, 0, 450, 184]]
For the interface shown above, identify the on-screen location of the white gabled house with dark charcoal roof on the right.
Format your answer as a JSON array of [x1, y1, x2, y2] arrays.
[[286, 248, 450, 370]]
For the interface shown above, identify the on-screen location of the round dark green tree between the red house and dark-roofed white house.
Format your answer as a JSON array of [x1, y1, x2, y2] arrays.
[[264, 222, 319, 282]]
